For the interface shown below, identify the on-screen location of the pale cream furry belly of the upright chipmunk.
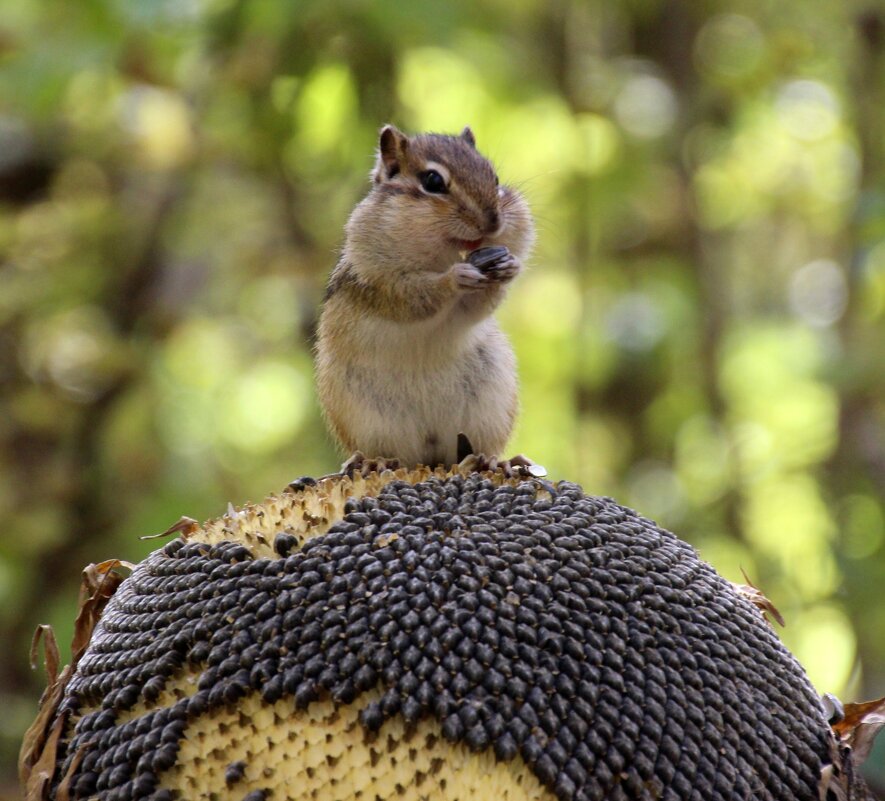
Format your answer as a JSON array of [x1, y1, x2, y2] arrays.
[[342, 320, 517, 465]]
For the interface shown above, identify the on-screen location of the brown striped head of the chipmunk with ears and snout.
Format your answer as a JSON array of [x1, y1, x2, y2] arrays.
[[372, 125, 527, 251]]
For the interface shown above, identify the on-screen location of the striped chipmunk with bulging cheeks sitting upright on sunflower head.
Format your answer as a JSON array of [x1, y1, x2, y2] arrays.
[[316, 125, 543, 474]]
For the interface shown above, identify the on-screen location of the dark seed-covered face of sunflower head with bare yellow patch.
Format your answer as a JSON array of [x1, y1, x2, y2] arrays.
[[53, 475, 828, 801]]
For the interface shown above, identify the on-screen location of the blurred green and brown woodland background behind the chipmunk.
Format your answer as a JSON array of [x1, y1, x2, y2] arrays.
[[0, 0, 885, 798]]
